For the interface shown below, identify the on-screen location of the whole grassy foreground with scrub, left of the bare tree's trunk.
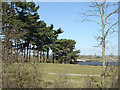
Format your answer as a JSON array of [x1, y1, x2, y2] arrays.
[[3, 63, 117, 88]]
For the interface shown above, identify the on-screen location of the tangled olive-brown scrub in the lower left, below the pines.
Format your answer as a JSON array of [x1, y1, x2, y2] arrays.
[[2, 63, 43, 88]]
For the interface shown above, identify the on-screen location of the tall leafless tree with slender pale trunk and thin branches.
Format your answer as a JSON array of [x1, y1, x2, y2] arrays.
[[80, 0, 120, 88]]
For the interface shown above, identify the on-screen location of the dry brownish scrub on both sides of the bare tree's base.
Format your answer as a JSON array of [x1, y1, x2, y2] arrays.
[[83, 66, 119, 88]]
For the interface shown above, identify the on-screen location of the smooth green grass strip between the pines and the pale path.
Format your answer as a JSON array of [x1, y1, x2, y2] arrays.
[[38, 64, 102, 74]]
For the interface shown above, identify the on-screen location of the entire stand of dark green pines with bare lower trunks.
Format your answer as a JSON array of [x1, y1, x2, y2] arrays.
[[1, 2, 80, 63]]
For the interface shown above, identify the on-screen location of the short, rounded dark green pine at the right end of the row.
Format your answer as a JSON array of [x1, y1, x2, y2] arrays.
[[55, 39, 80, 63]]
